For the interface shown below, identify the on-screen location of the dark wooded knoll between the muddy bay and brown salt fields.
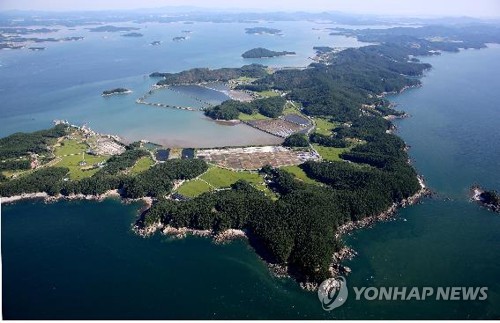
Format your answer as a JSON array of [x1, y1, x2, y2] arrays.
[[205, 96, 286, 120]]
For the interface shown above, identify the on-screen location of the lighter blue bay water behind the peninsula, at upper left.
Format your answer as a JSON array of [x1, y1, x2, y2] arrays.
[[0, 22, 363, 147]]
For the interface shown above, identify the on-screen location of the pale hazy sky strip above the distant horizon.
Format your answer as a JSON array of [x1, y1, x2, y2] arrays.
[[0, 0, 500, 17]]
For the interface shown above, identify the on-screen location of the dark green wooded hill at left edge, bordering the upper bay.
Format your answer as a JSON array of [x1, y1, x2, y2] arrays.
[[0, 124, 67, 160]]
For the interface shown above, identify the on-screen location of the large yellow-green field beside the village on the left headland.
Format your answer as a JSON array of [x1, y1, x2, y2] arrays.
[[54, 139, 109, 180]]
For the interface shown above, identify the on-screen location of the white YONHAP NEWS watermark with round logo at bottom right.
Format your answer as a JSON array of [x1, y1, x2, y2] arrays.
[[318, 276, 488, 311]]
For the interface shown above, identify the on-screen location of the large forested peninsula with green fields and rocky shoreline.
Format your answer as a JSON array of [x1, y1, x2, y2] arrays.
[[4, 22, 500, 290]]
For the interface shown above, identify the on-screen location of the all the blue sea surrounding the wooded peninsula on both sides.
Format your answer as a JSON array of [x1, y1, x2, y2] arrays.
[[0, 22, 500, 319]]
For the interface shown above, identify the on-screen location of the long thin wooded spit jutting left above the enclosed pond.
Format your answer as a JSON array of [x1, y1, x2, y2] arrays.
[[150, 64, 267, 86]]
